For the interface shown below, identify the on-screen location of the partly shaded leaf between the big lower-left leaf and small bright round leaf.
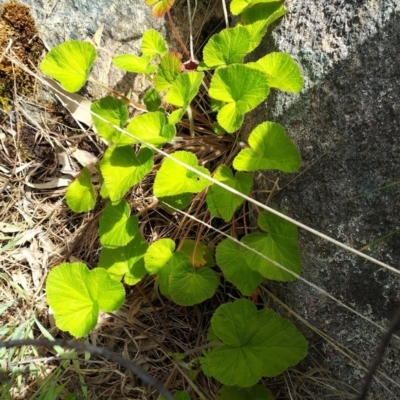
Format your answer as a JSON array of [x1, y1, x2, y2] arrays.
[[97, 232, 149, 285]]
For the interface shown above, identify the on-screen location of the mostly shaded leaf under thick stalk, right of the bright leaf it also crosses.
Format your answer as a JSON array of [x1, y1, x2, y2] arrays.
[[206, 165, 253, 222]]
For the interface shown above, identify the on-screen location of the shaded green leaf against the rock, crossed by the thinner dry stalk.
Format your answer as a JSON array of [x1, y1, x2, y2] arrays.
[[241, 211, 301, 281]]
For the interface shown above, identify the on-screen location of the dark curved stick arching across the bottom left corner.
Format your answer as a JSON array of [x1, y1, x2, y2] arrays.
[[0, 338, 175, 400]]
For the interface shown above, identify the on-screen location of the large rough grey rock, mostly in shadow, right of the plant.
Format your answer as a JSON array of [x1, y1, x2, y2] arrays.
[[247, 0, 400, 399]]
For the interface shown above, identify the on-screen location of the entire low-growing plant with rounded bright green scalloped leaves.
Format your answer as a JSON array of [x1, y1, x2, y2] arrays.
[[40, 0, 307, 399]]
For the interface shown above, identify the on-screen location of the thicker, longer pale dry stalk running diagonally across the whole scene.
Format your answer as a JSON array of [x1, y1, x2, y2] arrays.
[[6, 55, 400, 275]]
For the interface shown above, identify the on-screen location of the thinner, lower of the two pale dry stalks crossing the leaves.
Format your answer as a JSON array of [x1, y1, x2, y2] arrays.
[[165, 203, 400, 340]]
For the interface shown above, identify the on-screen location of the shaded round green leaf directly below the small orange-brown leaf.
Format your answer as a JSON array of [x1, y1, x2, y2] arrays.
[[169, 259, 219, 306]]
